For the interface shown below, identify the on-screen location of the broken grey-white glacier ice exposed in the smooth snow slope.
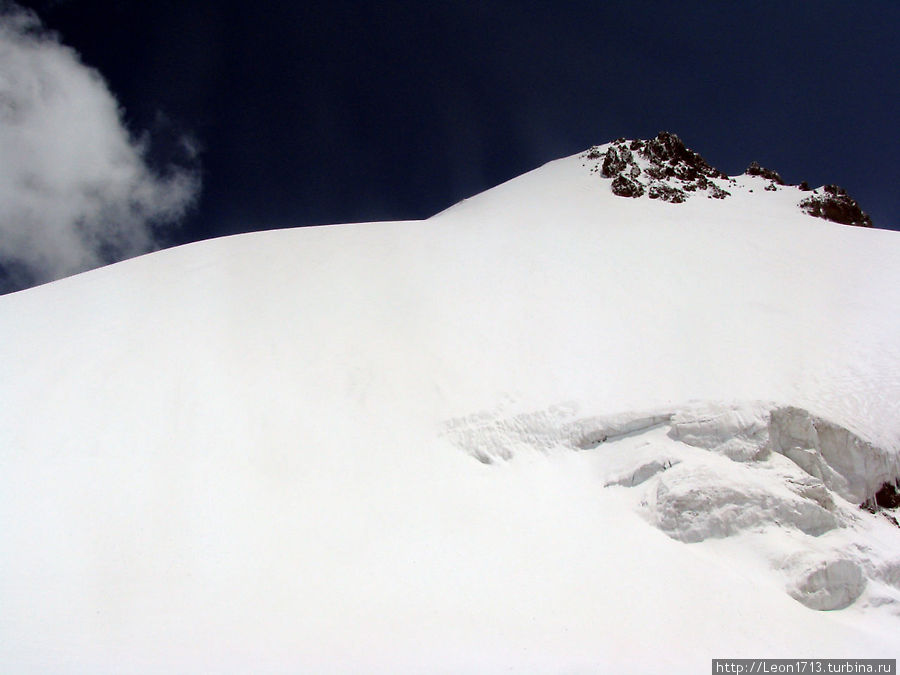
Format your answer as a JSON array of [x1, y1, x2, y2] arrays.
[[445, 401, 900, 610]]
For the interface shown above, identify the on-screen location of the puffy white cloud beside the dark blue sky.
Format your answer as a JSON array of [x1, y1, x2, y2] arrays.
[[0, 6, 199, 290]]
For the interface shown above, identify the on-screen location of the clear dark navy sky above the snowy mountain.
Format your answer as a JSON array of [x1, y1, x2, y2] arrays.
[[14, 0, 900, 243]]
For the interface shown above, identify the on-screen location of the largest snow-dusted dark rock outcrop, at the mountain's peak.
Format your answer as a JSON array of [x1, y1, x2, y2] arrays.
[[583, 131, 729, 204]]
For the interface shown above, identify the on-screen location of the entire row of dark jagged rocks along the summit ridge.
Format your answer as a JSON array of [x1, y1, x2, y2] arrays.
[[582, 131, 872, 227]]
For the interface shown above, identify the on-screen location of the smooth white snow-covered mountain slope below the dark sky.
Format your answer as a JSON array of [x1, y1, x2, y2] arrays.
[[0, 135, 900, 673]]
